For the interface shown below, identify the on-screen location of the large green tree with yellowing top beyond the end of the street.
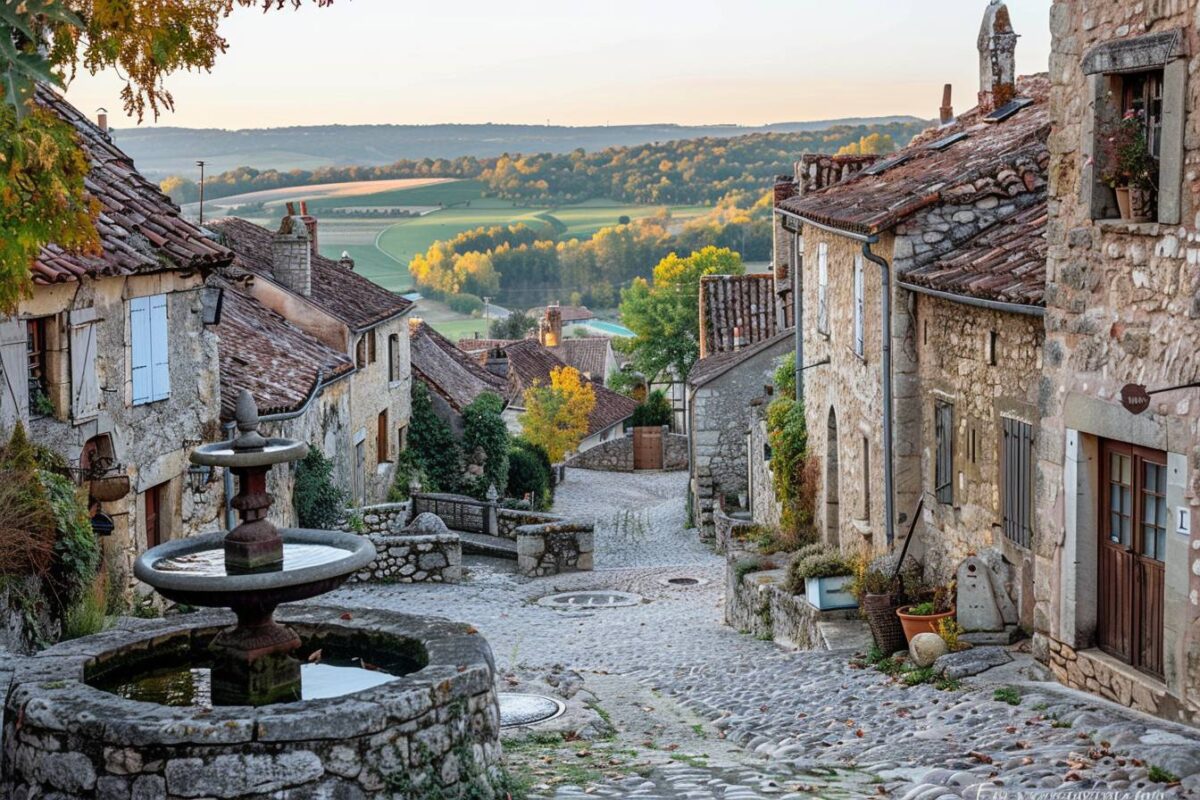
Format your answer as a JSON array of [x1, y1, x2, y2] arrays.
[[620, 247, 745, 378]]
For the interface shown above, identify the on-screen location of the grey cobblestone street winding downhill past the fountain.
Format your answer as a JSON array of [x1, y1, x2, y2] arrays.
[[328, 470, 1200, 800]]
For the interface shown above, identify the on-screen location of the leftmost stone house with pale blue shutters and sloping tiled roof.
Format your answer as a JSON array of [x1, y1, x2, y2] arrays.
[[0, 88, 233, 587]]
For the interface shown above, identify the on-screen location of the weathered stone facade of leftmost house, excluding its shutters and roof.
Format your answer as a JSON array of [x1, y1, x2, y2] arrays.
[[17, 272, 220, 592]]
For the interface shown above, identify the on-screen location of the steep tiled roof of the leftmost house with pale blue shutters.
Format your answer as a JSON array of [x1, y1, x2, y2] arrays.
[[30, 86, 233, 284]]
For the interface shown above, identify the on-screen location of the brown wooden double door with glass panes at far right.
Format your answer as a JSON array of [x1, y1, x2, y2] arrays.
[[1097, 441, 1166, 678]]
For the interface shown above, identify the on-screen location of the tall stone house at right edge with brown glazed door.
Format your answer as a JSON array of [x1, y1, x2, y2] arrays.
[[1033, 0, 1200, 724]]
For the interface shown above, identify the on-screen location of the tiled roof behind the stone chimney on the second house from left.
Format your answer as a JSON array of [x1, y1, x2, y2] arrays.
[[209, 217, 413, 330]]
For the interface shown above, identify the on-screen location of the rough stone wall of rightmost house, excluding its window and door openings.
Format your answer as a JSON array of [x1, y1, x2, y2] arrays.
[[1034, 0, 1200, 720]]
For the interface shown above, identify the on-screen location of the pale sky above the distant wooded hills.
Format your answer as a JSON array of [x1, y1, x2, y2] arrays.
[[68, 0, 1051, 128]]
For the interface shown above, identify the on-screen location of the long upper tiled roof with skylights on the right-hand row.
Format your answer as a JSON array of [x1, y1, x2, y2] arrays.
[[780, 74, 1050, 234]]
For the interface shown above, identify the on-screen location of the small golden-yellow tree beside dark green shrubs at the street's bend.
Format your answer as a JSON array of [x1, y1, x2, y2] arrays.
[[521, 367, 596, 463]]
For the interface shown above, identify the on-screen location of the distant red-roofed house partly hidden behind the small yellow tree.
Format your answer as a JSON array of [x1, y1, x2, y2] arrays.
[[467, 339, 637, 452]]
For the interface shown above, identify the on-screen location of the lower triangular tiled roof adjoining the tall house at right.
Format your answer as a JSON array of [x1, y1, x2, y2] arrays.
[[900, 197, 1048, 306]]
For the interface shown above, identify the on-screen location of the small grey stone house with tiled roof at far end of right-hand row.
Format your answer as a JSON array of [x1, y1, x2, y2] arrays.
[[686, 272, 794, 539]]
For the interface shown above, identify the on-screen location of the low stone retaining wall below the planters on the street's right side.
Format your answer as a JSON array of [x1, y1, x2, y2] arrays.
[[725, 551, 858, 650]]
